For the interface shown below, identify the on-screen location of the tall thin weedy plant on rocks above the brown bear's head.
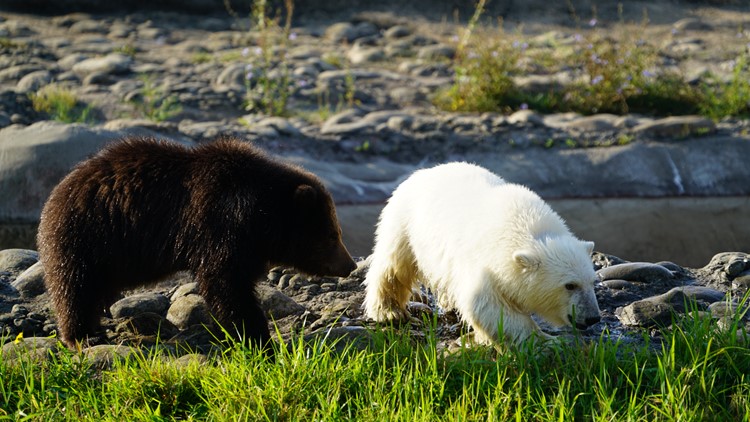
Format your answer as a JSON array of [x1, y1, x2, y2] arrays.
[[242, 0, 296, 116]]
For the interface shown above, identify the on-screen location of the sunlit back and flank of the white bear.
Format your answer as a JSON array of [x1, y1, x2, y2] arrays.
[[379, 163, 569, 302]]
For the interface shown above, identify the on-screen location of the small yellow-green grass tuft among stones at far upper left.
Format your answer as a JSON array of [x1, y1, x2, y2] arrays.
[[29, 85, 93, 123]]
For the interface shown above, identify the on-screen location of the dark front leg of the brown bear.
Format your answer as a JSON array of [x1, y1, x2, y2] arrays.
[[195, 271, 273, 355]]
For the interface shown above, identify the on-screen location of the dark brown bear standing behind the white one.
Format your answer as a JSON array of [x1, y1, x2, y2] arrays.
[[37, 137, 356, 350]]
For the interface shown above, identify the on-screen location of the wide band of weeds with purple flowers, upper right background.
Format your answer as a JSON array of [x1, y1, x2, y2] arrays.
[[434, 2, 750, 120]]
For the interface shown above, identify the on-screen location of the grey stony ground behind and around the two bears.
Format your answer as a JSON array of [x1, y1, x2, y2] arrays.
[[0, 1, 750, 362]]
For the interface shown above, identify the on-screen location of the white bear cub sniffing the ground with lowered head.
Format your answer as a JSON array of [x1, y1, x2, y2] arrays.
[[364, 162, 600, 344]]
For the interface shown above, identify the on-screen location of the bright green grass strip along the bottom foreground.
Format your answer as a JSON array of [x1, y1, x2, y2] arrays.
[[0, 317, 750, 421]]
